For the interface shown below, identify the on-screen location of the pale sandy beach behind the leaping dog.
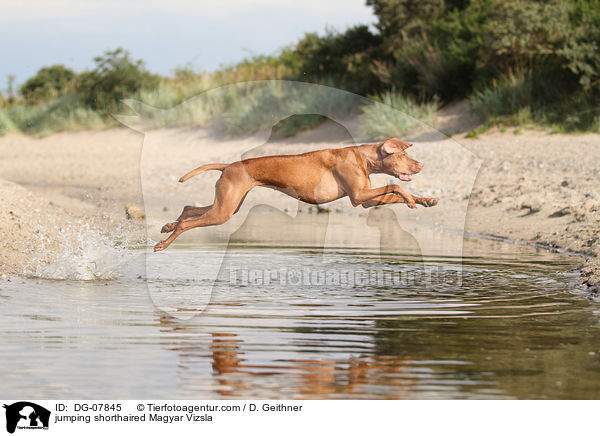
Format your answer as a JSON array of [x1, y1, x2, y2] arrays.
[[0, 117, 600, 291]]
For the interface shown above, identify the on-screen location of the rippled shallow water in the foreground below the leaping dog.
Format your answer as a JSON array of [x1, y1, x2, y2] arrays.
[[0, 242, 600, 399]]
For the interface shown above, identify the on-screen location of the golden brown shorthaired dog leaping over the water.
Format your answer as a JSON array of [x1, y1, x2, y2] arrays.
[[154, 138, 438, 251]]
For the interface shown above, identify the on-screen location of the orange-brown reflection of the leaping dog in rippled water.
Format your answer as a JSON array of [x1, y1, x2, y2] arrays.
[[160, 314, 415, 398]]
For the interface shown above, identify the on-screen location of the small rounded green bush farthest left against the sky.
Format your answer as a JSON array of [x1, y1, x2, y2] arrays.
[[21, 65, 75, 104]]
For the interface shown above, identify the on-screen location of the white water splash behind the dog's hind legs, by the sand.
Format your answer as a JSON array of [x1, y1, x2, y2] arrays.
[[24, 224, 132, 280]]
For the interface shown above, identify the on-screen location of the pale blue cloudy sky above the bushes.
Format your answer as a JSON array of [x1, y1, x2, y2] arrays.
[[0, 0, 375, 91]]
